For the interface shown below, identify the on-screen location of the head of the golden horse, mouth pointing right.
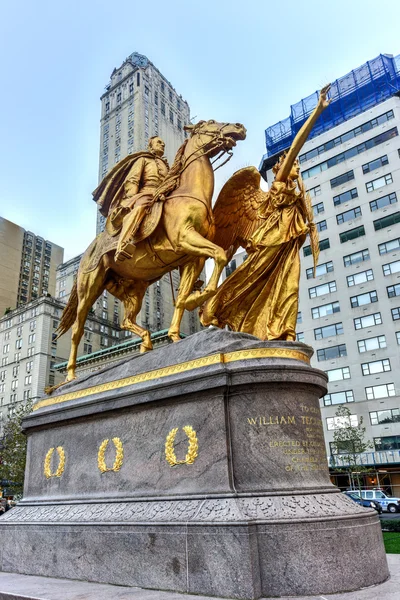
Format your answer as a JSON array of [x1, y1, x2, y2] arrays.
[[185, 119, 246, 157]]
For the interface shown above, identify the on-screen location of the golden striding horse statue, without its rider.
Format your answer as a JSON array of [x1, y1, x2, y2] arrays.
[[58, 120, 246, 381]]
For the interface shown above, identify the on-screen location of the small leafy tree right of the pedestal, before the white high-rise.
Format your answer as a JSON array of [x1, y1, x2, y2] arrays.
[[332, 404, 374, 491]]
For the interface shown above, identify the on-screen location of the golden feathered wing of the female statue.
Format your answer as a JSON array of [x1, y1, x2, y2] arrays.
[[213, 167, 269, 253]]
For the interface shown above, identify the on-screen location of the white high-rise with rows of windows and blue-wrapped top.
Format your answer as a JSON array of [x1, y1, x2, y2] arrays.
[[260, 55, 400, 495]]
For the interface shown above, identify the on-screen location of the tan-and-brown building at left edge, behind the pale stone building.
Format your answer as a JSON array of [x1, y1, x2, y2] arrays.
[[0, 217, 64, 316]]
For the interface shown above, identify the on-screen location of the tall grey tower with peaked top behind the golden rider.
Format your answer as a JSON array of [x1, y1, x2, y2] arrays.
[[97, 52, 190, 233]]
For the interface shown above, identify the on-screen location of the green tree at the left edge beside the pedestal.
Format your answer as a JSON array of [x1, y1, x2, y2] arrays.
[[0, 403, 32, 494]]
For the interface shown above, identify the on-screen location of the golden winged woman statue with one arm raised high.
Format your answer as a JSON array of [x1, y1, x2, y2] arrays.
[[201, 85, 330, 340]]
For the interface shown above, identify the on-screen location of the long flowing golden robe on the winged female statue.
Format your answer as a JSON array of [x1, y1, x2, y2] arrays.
[[209, 180, 309, 340]]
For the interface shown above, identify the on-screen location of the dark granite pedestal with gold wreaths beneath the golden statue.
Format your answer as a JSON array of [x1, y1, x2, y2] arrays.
[[0, 329, 389, 600]]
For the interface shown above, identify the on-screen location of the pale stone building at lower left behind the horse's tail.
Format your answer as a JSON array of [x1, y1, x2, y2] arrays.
[[0, 296, 126, 437]]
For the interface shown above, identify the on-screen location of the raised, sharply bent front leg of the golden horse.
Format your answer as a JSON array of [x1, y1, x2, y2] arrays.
[[179, 227, 228, 310]]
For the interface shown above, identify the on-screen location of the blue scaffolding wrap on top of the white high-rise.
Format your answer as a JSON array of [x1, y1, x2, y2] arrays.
[[262, 54, 400, 162]]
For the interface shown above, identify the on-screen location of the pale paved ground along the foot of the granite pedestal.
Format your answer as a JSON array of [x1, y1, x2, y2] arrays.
[[0, 554, 400, 600]]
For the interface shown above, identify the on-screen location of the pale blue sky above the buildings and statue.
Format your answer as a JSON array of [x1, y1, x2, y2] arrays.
[[0, 0, 400, 260]]
